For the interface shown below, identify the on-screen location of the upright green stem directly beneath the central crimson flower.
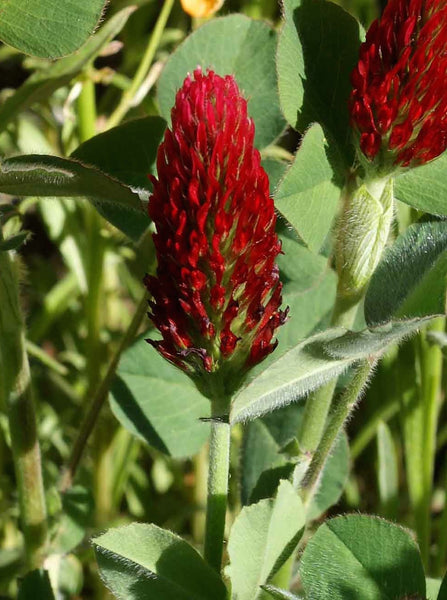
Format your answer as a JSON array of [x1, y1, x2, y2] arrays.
[[204, 403, 231, 573]]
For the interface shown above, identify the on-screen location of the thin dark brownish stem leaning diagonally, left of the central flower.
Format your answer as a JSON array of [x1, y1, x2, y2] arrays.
[[60, 293, 147, 491]]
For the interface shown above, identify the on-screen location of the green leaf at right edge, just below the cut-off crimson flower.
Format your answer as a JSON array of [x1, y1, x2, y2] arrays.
[[394, 154, 447, 216]]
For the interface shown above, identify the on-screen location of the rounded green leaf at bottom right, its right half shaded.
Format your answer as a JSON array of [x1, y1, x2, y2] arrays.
[[300, 515, 425, 600]]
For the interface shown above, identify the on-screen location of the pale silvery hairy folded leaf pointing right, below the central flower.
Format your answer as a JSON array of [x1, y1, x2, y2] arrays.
[[230, 319, 428, 423]]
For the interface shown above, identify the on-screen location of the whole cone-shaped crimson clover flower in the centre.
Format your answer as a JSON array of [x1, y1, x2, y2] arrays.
[[145, 68, 286, 396]]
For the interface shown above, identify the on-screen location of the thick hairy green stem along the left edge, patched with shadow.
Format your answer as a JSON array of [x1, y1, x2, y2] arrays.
[[0, 230, 47, 569]]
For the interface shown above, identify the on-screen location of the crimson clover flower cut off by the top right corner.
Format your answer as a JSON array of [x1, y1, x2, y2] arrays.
[[351, 0, 447, 169]]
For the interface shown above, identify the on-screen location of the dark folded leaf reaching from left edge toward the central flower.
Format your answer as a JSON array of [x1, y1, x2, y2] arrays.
[[0, 154, 145, 241]]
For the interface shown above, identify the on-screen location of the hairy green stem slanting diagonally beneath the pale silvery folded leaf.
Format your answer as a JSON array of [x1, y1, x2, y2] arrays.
[[301, 360, 373, 504]]
